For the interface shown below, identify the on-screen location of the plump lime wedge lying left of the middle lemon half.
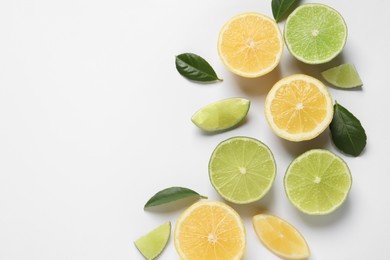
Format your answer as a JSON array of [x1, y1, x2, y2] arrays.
[[191, 98, 250, 132]]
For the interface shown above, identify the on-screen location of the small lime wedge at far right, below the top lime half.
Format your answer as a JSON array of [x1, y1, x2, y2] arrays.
[[321, 64, 363, 88]]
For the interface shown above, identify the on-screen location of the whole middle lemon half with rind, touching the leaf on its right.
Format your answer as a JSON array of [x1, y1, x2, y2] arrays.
[[265, 74, 333, 142]]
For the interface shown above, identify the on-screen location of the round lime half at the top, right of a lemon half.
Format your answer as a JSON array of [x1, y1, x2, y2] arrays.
[[284, 4, 347, 64]]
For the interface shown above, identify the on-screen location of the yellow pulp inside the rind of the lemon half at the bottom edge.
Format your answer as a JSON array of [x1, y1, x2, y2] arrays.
[[176, 206, 245, 260]]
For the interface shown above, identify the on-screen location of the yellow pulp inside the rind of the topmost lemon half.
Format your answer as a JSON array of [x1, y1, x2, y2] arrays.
[[221, 15, 282, 73]]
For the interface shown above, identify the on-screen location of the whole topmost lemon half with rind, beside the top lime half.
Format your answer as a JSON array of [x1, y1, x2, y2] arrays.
[[218, 13, 283, 78]]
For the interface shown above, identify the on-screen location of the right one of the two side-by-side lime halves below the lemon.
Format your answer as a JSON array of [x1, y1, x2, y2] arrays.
[[284, 149, 352, 215]]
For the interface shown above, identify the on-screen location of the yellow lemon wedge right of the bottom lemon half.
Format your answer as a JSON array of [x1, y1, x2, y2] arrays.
[[252, 214, 310, 259]]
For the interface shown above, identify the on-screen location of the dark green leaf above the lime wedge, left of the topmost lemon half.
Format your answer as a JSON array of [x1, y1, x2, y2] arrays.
[[176, 53, 222, 82]]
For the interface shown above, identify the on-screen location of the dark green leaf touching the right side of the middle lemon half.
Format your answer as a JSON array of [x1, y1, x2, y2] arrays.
[[329, 103, 367, 156]]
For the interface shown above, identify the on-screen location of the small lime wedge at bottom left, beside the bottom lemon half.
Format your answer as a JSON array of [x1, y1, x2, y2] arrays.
[[134, 222, 171, 260]]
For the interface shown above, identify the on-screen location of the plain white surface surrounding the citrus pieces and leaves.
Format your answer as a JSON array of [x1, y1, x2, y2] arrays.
[[0, 0, 390, 260]]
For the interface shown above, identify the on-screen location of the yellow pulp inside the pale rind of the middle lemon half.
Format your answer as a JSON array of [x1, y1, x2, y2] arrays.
[[271, 80, 328, 134]]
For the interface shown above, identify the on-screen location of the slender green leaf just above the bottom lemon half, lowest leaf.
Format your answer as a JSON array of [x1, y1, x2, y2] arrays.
[[144, 187, 207, 209]]
